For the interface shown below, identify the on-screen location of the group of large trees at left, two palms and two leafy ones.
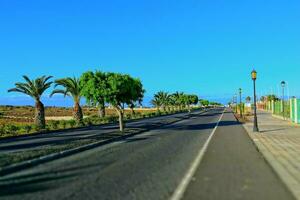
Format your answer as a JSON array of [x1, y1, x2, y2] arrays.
[[8, 71, 145, 132]]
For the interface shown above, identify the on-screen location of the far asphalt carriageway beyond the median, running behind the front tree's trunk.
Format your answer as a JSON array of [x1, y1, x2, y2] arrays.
[[0, 110, 202, 153]]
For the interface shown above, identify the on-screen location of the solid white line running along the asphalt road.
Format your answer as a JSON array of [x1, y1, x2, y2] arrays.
[[170, 109, 225, 200]]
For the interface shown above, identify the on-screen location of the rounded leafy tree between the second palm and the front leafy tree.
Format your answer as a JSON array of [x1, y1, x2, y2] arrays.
[[80, 71, 108, 118]]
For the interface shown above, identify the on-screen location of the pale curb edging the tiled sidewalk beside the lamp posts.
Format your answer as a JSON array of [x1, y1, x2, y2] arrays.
[[242, 124, 300, 200]]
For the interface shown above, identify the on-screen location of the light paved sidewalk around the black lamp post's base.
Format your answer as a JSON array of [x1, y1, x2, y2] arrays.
[[244, 111, 300, 200]]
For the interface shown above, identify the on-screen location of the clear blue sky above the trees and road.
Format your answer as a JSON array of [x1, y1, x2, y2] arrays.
[[0, 0, 300, 106]]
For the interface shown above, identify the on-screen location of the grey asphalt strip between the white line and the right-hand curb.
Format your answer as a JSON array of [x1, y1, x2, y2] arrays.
[[183, 112, 294, 200]]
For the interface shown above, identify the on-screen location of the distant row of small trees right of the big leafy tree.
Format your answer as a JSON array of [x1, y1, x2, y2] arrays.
[[151, 91, 199, 112]]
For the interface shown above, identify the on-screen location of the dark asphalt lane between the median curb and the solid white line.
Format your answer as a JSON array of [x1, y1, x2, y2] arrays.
[[0, 110, 222, 200]]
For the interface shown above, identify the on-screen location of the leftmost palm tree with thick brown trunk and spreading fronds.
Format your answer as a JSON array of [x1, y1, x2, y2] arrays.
[[8, 75, 53, 129]]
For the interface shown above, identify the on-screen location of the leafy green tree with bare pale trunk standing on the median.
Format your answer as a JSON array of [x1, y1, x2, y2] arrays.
[[106, 73, 143, 132]]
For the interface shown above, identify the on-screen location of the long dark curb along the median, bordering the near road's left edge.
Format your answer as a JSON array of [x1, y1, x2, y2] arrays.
[[0, 110, 208, 176]]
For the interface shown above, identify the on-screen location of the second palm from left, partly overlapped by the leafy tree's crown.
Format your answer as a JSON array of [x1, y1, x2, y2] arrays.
[[50, 77, 83, 123]]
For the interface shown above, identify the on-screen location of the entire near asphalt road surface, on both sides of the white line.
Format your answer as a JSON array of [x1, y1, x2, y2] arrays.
[[0, 109, 292, 200]]
